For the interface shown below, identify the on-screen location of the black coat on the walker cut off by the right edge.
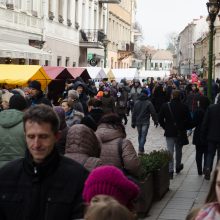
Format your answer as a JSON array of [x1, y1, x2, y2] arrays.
[[202, 103, 220, 143]]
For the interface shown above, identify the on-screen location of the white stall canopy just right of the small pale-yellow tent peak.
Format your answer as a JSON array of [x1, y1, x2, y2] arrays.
[[112, 68, 138, 82]]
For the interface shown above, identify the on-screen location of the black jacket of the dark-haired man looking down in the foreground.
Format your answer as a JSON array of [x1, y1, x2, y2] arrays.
[[0, 150, 87, 220]]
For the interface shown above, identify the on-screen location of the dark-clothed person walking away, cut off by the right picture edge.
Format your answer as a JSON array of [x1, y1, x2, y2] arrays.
[[201, 97, 220, 180]]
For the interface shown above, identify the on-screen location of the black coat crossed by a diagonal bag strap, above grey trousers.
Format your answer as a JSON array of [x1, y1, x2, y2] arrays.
[[159, 99, 193, 137]]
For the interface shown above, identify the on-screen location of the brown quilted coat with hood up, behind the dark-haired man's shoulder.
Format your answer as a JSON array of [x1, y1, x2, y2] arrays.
[[65, 124, 102, 171]]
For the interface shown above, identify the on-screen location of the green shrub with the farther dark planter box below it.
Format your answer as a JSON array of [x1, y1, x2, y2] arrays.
[[140, 150, 172, 200]]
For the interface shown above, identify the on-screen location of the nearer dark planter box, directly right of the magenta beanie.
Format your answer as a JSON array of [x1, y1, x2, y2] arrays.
[[135, 174, 154, 218]]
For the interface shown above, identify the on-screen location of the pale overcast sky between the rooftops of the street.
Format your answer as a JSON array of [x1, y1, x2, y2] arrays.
[[136, 0, 208, 49]]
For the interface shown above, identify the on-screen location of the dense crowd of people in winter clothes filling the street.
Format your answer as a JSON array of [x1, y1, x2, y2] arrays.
[[0, 71, 220, 220]]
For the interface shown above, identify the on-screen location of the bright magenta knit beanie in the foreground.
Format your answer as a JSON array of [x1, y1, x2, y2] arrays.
[[83, 166, 139, 208]]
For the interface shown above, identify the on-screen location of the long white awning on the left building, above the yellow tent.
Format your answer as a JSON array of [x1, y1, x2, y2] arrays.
[[0, 41, 52, 60]]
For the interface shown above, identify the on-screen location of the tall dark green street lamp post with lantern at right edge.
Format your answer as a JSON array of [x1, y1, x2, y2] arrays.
[[206, 0, 220, 101]]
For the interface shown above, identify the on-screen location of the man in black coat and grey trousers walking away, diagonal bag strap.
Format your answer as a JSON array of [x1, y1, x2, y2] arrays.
[[159, 90, 192, 179]]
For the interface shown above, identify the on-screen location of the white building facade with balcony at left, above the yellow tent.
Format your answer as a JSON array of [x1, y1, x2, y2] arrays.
[[0, 0, 107, 66]]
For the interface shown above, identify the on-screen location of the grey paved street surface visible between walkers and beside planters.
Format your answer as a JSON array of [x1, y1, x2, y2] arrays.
[[126, 118, 210, 220]]
